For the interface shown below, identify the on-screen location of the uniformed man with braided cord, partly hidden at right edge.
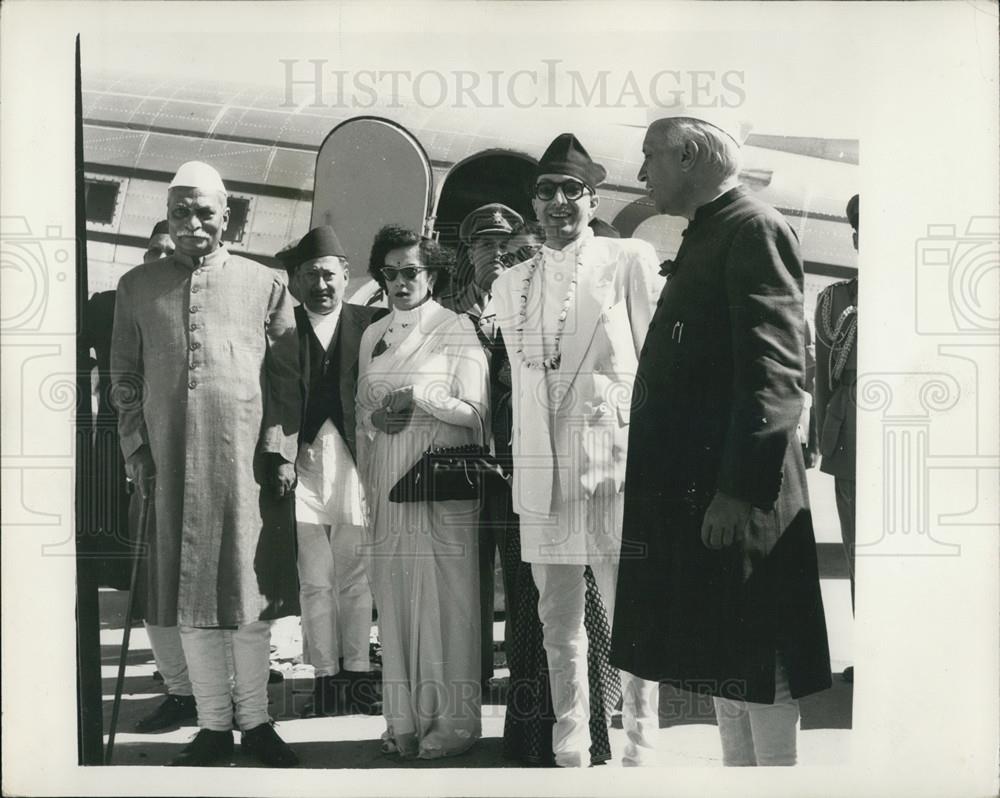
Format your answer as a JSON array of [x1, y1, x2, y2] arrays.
[[816, 194, 859, 682]]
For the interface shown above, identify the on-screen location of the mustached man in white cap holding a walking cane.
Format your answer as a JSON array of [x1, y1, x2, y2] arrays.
[[111, 161, 301, 767]]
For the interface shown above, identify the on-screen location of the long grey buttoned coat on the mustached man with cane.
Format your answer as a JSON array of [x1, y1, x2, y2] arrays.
[[111, 248, 301, 627]]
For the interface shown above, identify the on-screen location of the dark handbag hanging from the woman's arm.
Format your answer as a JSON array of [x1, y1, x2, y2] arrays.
[[389, 411, 510, 502]]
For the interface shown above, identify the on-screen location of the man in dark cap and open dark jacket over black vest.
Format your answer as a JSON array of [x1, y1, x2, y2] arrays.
[[278, 225, 385, 715]]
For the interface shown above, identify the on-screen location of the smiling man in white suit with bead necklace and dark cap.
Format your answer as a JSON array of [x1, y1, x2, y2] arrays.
[[493, 133, 658, 767]]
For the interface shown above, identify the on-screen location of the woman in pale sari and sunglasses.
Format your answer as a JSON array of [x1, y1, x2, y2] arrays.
[[357, 226, 489, 759]]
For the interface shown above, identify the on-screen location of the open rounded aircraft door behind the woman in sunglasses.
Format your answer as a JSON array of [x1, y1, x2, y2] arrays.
[[309, 116, 434, 296]]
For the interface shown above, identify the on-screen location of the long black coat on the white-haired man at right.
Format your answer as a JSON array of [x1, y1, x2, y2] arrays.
[[611, 187, 831, 703]]
